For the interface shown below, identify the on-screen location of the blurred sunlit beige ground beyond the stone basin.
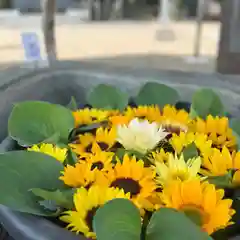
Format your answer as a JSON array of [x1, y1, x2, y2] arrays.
[[0, 17, 219, 72]]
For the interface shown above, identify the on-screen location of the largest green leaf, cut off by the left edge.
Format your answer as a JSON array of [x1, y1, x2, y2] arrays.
[[0, 151, 64, 215]]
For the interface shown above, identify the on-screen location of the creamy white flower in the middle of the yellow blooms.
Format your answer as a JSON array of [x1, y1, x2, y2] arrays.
[[117, 118, 169, 154]]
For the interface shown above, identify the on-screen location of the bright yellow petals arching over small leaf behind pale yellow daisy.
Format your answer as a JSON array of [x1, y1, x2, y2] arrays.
[[169, 132, 213, 156]]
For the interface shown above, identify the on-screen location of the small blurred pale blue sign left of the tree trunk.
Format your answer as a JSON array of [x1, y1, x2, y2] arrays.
[[21, 32, 42, 61]]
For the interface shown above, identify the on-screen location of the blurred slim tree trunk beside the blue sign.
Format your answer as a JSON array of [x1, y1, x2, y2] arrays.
[[42, 0, 57, 66]]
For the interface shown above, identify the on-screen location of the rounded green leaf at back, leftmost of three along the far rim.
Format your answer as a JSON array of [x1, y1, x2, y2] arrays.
[[87, 84, 128, 110]]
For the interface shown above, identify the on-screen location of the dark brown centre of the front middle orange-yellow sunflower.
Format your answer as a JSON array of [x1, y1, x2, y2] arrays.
[[111, 178, 141, 197]]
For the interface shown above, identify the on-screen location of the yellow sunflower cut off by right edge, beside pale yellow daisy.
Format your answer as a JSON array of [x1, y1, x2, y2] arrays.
[[201, 147, 240, 186]]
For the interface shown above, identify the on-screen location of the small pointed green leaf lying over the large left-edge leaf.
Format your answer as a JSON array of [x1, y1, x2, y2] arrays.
[[30, 188, 74, 209]]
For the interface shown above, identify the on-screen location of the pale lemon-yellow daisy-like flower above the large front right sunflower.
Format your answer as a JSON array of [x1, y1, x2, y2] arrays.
[[153, 154, 201, 187]]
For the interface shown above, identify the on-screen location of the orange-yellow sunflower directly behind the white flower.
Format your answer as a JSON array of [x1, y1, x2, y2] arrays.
[[125, 105, 161, 122]]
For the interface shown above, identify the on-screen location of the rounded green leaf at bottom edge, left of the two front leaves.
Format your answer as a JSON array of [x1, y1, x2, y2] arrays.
[[93, 199, 141, 240]]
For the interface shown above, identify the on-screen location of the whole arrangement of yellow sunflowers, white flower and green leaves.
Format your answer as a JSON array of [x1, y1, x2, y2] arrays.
[[0, 83, 240, 240]]
